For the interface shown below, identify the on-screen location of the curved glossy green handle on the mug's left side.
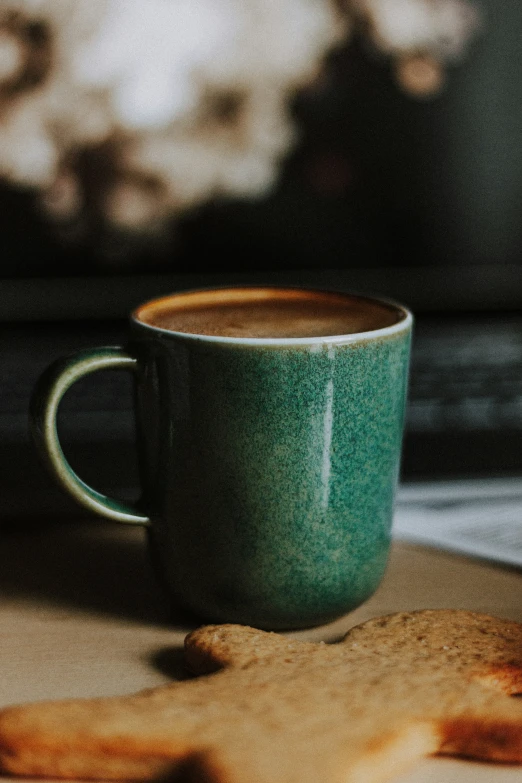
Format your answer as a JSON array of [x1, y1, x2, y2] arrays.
[[29, 347, 150, 525]]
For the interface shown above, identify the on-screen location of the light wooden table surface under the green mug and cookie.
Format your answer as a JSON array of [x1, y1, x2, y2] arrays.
[[0, 519, 522, 783]]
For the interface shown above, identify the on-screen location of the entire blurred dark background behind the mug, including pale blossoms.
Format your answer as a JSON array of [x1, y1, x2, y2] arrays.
[[0, 0, 522, 521]]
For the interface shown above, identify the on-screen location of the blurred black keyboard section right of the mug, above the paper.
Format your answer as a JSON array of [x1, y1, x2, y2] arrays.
[[403, 313, 522, 480]]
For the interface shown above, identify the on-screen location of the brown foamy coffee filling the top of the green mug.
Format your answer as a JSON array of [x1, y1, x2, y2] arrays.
[[136, 288, 404, 339]]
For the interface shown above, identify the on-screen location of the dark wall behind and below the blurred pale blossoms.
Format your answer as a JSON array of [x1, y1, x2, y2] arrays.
[[0, 0, 522, 276]]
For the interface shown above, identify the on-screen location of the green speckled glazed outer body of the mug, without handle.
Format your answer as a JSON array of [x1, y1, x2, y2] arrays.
[[128, 290, 410, 629]]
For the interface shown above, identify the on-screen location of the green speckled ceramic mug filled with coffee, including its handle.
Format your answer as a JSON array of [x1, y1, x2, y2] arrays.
[[31, 287, 412, 629]]
